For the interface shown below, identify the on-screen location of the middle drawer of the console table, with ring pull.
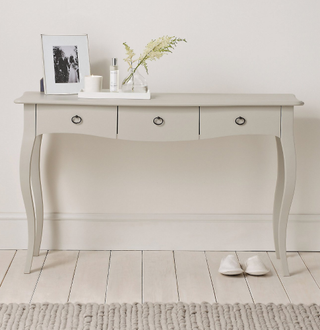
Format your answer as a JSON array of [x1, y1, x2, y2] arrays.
[[118, 107, 199, 141]]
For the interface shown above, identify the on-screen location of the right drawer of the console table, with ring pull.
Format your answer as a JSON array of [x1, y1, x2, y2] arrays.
[[200, 107, 280, 139]]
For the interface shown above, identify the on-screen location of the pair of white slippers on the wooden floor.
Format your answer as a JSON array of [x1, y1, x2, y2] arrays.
[[219, 254, 270, 276]]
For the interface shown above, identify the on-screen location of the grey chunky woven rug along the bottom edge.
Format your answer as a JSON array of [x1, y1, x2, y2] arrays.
[[0, 303, 320, 330]]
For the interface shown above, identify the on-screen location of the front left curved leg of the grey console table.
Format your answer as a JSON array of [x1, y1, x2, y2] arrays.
[[20, 105, 35, 273]]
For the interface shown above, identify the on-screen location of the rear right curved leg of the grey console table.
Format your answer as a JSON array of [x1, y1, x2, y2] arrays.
[[273, 136, 284, 259]]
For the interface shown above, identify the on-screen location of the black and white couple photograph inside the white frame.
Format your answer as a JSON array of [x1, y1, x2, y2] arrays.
[[53, 46, 80, 84]]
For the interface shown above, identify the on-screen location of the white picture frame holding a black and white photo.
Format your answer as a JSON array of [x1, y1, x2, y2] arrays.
[[41, 34, 90, 94]]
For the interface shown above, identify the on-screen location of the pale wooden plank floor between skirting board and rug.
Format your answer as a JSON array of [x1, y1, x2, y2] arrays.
[[0, 250, 320, 304]]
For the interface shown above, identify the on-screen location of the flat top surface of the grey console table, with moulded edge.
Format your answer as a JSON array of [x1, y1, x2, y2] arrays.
[[15, 92, 303, 107]]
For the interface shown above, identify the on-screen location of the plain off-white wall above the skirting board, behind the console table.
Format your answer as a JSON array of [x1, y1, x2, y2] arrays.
[[0, 0, 320, 247]]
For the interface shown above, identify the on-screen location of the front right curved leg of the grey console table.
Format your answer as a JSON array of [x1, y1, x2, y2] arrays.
[[278, 107, 296, 276]]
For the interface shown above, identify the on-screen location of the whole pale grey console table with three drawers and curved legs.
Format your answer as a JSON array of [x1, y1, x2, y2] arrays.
[[15, 92, 303, 276]]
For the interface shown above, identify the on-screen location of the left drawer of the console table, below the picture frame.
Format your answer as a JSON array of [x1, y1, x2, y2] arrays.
[[37, 105, 117, 138]]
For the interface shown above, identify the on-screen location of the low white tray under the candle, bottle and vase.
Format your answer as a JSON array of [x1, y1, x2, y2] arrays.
[[78, 89, 151, 100]]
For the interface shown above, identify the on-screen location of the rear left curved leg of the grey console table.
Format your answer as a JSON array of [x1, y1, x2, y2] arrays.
[[31, 135, 43, 256]]
